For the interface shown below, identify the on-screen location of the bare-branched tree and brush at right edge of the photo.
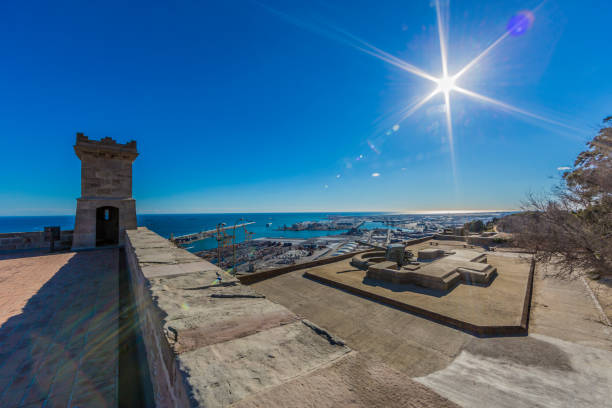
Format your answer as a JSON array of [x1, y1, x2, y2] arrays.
[[500, 116, 612, 276]]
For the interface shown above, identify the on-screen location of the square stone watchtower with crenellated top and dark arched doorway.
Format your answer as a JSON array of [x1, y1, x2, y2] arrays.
[[72, 133, 138, 249]]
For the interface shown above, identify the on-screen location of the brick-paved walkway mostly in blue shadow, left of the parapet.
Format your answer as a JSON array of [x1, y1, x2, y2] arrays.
[[0, 249, 119, 408]]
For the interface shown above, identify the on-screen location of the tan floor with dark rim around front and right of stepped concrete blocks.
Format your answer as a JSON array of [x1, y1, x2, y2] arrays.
[[304, 255, 531, 334]]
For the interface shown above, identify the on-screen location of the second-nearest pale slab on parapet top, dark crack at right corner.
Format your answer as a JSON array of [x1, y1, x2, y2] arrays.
[[181, 321, 350, 407]]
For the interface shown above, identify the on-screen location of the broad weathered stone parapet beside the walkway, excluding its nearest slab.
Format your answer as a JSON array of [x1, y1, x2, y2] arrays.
[[125, 228, 351, 407]]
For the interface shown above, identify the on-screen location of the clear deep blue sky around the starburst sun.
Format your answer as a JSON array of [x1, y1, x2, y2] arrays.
[[0, 0, 612, 215]]
